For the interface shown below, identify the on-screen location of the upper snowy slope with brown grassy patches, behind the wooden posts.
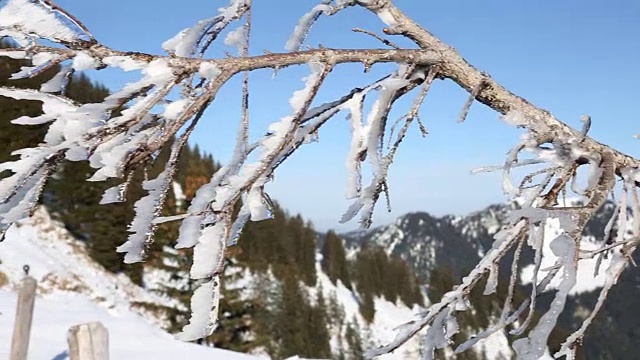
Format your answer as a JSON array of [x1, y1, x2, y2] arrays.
[[0, 207, 178, 325]]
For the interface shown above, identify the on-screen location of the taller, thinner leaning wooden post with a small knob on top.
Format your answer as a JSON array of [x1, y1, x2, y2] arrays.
[[10, 276, 38, 360]]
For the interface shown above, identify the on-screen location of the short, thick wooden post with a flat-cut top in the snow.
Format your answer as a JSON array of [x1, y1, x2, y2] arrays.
[[67, 321, 109, 360]]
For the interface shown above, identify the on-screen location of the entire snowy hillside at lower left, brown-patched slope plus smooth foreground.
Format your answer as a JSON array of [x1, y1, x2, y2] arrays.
[[0, 208, 256, 360]]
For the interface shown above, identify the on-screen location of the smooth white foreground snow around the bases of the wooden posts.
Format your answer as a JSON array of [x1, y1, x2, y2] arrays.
[[0, 290, 257, 360]]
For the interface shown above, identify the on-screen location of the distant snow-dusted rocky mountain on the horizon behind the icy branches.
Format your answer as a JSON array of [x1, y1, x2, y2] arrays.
[[342, 200, 614, 286]]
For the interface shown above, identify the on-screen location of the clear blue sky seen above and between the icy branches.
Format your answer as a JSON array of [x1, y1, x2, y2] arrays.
[[57, 0, 640, 230]]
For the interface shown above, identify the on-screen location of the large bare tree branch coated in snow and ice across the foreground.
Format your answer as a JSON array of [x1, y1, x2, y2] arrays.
[[0, 0, 640, 359]]
